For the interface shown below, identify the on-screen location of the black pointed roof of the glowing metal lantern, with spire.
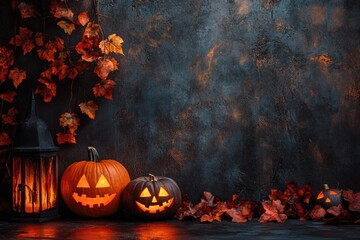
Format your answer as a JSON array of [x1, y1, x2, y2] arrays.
[[11, 93, 59, 153]]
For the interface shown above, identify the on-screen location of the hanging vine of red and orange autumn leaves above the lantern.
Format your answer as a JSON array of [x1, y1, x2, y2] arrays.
[[0, 0, 124, 146]]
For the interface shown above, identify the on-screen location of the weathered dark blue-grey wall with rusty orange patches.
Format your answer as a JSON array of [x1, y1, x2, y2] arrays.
[[0, 0, 360, 206]]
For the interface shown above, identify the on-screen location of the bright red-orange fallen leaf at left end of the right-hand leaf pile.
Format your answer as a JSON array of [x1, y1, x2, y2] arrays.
[[259, 200, 287, 223]]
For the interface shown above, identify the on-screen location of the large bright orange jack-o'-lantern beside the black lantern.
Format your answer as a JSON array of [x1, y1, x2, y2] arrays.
[[60, 147, 130, 217]]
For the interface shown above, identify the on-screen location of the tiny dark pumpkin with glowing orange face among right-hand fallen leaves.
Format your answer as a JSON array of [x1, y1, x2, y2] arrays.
[[316, 184, 342, 209]]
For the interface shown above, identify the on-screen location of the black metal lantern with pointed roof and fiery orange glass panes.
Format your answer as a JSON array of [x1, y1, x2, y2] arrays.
[[11, 94, 58, 222]]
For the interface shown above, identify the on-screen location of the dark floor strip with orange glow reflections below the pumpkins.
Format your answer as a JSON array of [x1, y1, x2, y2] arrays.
[[0, 219, 360, 240]]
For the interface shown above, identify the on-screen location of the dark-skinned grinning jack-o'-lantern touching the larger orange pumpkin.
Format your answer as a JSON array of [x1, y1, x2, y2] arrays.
[[121, 174, 181, 220]]
